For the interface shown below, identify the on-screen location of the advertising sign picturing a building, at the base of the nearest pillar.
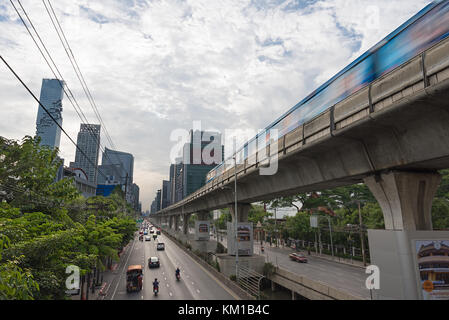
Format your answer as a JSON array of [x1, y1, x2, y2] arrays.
[[415, 240, 449, 300]]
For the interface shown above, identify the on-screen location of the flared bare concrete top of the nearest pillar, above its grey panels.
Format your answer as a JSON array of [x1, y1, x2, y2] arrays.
[[364, 171, 441, 231]]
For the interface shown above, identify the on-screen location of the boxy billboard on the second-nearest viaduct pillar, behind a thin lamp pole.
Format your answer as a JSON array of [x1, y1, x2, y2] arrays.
[[227, 222, 254, 256]]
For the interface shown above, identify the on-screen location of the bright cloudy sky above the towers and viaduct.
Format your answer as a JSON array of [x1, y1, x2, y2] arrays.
[[0, 0, 431, 210]]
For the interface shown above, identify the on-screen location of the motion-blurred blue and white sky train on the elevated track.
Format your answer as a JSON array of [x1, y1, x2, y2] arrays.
[[206, 0, 449, 183]]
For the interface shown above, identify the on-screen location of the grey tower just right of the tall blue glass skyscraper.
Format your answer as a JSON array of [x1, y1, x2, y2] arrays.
[[70, 123, 101, 184]]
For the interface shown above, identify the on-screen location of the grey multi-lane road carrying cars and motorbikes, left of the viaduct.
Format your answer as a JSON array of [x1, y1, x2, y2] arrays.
[[105, 230, 238, 300]]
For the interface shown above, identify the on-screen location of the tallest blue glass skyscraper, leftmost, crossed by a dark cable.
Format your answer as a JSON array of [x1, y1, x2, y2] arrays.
[[36, 79, 64, 148]]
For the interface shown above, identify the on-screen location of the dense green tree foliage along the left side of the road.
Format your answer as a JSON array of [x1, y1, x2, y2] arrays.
[[0, 137, 136, 299]]
